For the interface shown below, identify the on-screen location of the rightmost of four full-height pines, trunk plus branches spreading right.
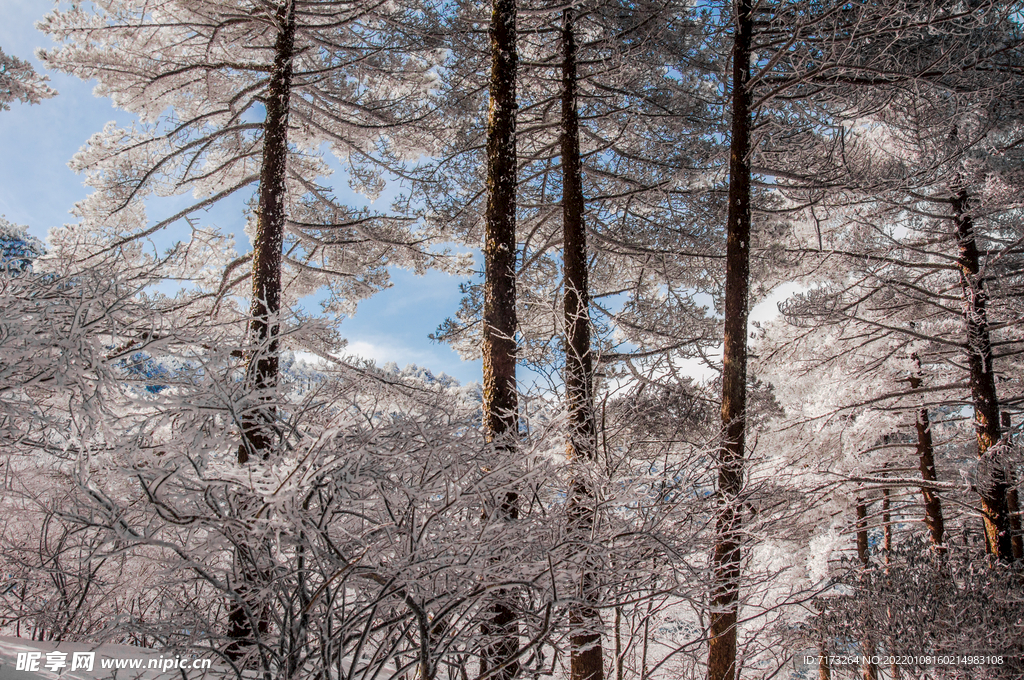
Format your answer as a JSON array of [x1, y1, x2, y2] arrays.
[[709, 3, 1024, 667]]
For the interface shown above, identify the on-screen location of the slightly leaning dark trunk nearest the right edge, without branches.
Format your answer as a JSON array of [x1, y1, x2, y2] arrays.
[[951, 189, 1013, 562]]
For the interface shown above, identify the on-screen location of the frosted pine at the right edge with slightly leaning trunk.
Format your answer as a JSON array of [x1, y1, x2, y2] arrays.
[[765, 6, 1020, 559]]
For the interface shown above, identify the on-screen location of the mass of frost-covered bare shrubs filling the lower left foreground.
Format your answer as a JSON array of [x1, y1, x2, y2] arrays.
[[0, 231, 720, 675]]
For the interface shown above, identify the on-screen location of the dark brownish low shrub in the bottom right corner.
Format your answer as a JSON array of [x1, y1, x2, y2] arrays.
[[802, 540, 1024, 680]]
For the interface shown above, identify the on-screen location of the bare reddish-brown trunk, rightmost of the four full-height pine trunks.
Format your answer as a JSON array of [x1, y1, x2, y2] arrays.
[[708, 0, 754, 680]]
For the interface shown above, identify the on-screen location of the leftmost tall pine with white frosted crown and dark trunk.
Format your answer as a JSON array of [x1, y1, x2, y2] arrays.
[[41, 0, 452, 461]]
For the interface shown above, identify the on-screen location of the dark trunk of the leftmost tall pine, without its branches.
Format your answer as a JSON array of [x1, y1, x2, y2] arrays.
[[225, 0, 295, 661]]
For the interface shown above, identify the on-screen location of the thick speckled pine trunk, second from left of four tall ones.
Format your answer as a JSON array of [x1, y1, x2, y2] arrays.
[[480, 0, 519, 680]]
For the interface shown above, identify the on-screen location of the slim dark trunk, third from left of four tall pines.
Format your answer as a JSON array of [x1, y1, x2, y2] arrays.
[[561, 8, 604, 680]]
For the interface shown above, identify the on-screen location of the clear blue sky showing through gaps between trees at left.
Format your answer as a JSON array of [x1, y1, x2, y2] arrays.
[[0, 0, 481, 383]]
